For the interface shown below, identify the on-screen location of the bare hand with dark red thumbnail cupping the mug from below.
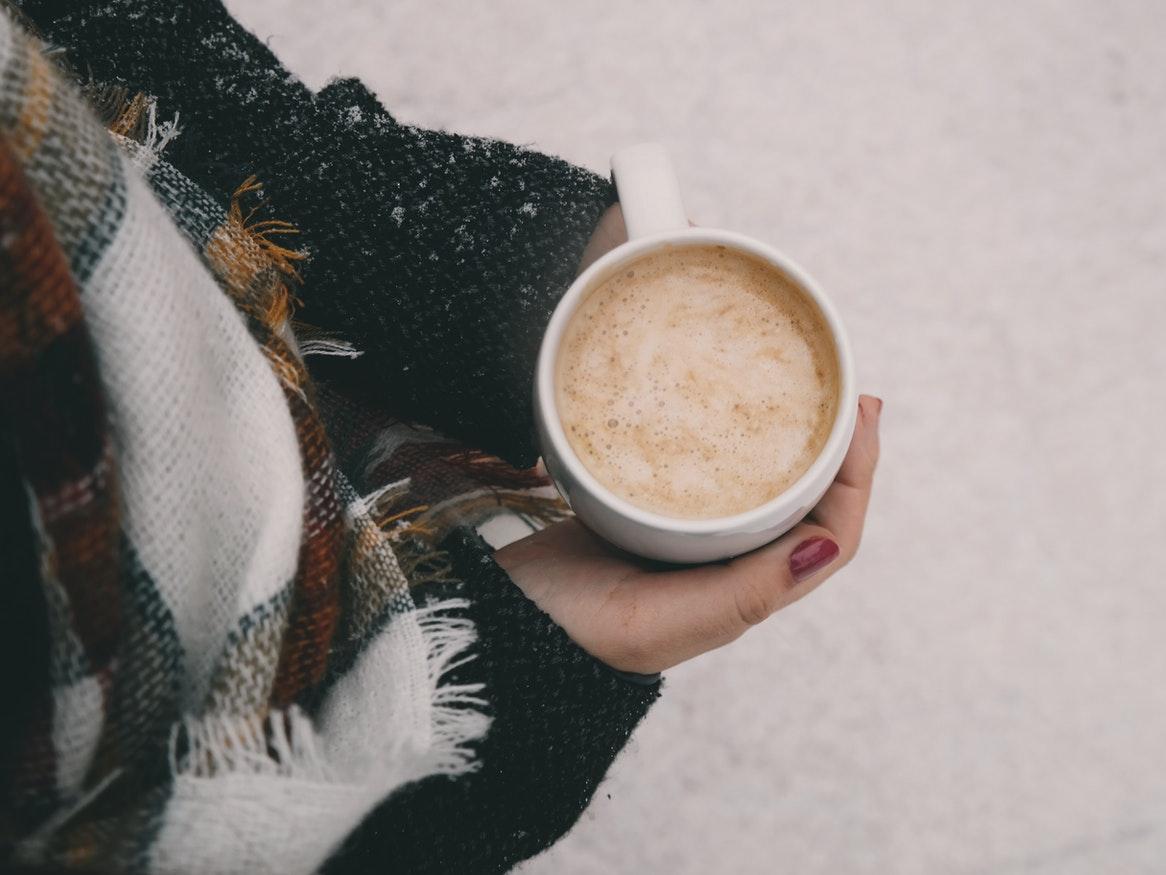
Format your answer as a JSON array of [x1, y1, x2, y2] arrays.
[[496, 396, 883, 674]]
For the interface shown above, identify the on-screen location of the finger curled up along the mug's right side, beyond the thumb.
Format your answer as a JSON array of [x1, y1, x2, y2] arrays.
[[809, 396, 883, 561]]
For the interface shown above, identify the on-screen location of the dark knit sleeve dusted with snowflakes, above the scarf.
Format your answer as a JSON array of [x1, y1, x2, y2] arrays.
[[22, 0, 614, 467]]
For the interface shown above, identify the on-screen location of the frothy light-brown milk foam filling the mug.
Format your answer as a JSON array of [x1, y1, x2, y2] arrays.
[[556, 245, 838, 519]]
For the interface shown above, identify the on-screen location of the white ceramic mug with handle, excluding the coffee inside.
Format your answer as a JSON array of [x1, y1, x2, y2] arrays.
[[534, 144, 858, 562]]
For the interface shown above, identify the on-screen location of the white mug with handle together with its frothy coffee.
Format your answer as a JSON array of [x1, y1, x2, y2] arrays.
[[533, 144, 858, 562]]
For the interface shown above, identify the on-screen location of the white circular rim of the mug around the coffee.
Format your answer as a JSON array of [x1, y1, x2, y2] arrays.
[[534, 228, 858, 534]]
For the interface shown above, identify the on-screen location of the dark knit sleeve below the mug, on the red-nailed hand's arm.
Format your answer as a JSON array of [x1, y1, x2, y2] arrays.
[[324, 529, 660, 875]]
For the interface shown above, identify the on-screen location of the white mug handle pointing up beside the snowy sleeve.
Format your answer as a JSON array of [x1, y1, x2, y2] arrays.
[[611, 142, 688, 240]]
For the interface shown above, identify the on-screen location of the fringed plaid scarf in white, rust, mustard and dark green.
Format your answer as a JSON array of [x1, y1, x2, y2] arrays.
[[0, 12, 564, 873]]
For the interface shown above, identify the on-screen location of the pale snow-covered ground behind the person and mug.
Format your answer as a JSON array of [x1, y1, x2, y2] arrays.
[[230, 0, 1166, 875]]
